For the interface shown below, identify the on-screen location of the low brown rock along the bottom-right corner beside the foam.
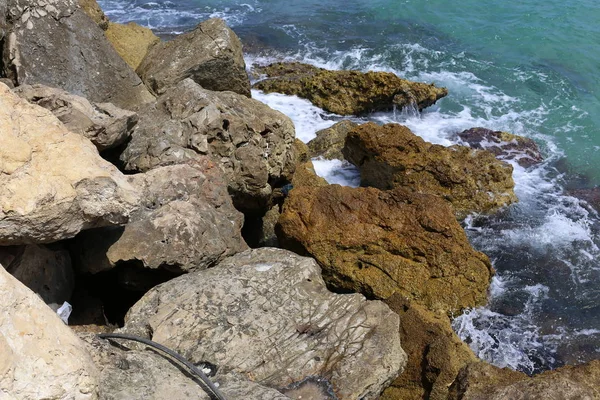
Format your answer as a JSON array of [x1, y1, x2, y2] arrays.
[[450, 360, 600, 400]]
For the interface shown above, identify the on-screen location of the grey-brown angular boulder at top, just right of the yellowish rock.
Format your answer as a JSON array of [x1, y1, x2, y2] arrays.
[[137, 18, 250, 97]]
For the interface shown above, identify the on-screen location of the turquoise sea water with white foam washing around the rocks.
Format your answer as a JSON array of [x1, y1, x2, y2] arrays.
[[99, 0, 600, 373]]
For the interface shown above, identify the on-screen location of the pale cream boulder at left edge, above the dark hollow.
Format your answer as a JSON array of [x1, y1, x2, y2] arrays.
[[0, 84, 140, 246]]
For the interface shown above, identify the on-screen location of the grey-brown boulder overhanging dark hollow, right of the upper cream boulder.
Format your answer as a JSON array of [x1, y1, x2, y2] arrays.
[[76, 157, 248, 273]]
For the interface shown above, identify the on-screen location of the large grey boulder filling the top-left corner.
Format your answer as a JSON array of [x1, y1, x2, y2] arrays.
[[2, 0, 153, 109]]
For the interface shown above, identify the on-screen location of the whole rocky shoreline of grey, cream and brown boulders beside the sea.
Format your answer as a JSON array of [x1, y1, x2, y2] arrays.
[[0, 0, 600, 400]]
